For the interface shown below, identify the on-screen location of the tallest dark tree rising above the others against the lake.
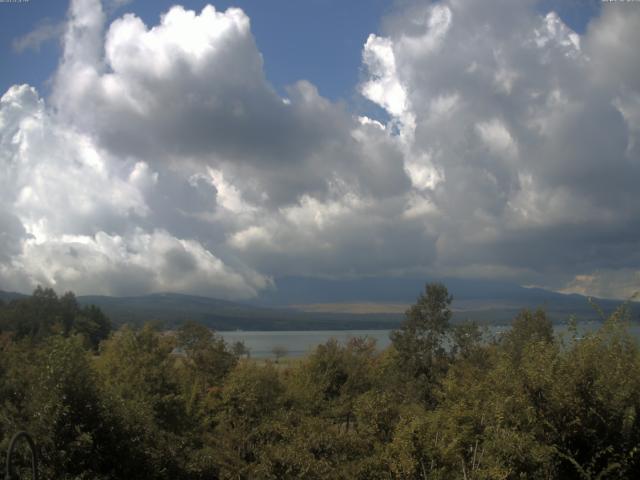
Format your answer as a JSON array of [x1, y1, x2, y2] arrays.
[[391, 283, 453, 403]]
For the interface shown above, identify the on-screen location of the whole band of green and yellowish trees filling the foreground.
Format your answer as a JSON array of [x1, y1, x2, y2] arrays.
[[0, 283, 640, 480]]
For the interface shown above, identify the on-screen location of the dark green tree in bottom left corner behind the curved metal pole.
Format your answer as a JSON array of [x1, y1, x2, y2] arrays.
[[0, 335, 135, 479]]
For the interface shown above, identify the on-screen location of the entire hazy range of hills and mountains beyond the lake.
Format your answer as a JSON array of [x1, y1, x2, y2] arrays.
[[0, 277, 640, 330]]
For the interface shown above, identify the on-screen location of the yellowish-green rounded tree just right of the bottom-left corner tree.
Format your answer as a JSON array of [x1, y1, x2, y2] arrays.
[[93, 324, 193, 479]]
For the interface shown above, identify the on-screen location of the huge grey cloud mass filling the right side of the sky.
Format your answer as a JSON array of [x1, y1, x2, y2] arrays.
[[363, 1, 640, 294]]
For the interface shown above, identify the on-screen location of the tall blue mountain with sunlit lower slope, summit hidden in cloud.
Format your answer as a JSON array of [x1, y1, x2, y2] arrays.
[[252, 277, 640, 323]]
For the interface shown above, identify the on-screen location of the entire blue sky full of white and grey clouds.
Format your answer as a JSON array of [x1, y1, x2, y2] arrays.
[[0, 0, 640, 299]]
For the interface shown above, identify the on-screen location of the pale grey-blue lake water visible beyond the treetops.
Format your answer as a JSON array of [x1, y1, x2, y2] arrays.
[[217, 322, 640, 358]]
